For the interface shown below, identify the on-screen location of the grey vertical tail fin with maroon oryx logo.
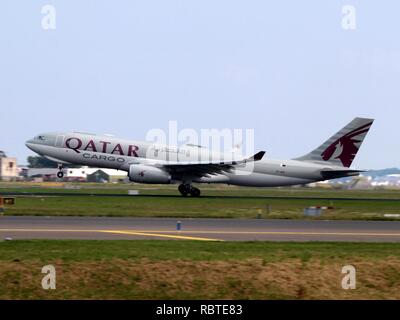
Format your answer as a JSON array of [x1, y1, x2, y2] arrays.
[[294, 118, 374, 168]]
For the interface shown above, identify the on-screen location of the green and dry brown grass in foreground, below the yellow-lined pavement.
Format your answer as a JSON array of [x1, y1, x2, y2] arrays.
[[0, 240, 400, 299]]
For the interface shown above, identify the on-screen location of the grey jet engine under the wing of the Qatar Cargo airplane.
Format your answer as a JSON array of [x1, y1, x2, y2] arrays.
[[128, 164, 171, 184]]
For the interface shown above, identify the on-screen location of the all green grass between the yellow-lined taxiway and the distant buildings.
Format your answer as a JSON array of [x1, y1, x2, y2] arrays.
[[0, 183, 400, 220]]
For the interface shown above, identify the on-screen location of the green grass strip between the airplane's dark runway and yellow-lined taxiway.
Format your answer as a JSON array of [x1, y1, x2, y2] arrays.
[[6, 191, 400, 220]]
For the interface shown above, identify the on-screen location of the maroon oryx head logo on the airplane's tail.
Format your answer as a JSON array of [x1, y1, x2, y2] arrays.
[[321, 122, 372, 168]]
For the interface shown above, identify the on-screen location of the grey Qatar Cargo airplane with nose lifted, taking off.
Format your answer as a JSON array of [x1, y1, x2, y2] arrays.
[[26, 118, 374, 197]]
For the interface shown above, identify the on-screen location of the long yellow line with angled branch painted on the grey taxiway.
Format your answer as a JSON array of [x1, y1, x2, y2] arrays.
[[0, 228, 400, 241]]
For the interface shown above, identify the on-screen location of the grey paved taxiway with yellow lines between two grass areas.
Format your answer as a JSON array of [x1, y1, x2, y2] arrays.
[[0, 216, 400, 242]]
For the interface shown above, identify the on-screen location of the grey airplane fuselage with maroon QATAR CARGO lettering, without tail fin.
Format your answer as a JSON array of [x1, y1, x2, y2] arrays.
[[26, 132, 343, 187]]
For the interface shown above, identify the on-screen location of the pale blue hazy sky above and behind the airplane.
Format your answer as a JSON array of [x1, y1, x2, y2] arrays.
[[0, 0, 400, 169]]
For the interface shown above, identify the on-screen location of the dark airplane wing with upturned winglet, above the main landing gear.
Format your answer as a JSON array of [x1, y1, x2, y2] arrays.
[[161, 151, 265, 177]]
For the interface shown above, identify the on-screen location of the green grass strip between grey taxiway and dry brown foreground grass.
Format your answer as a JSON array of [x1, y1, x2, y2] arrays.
[[0, 240, 400, 262]]
